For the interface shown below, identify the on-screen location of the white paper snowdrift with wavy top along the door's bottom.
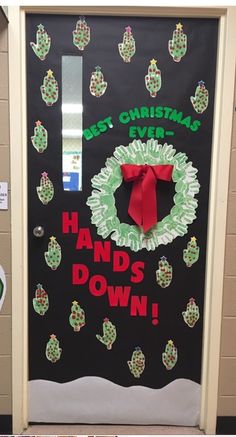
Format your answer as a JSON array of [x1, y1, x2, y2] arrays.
[[29, 376, 200, 426]]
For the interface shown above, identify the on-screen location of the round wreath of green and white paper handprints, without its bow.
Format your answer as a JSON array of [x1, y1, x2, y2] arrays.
[[87, 139, 200, 252]]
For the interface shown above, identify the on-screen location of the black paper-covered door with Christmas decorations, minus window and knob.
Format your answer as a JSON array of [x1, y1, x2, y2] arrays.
[[27, 15, 218, 426]]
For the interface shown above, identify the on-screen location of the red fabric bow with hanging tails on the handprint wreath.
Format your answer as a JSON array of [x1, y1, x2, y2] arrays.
[[121, 164, 173, 232]]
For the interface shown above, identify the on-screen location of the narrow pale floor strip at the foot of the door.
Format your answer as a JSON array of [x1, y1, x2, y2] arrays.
[[23, 425, 204, 436]]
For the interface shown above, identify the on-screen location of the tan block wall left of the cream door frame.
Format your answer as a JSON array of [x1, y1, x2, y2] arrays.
[[0, 10, 12, 415]]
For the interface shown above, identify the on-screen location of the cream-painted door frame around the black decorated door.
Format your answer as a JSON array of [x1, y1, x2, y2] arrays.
[[9, 5, 236, 434]]
